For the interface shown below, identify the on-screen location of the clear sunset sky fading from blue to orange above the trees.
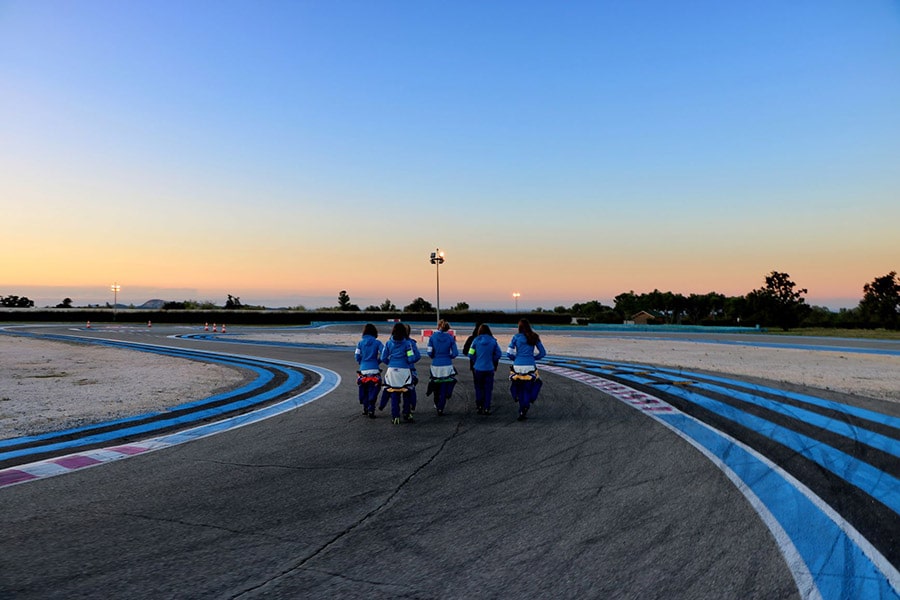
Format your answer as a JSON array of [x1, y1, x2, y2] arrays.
[[0, 0, 900, 309]]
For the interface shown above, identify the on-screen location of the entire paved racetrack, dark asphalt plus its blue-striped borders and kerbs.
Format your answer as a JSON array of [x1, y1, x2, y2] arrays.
[[0, 326, 900, 599]]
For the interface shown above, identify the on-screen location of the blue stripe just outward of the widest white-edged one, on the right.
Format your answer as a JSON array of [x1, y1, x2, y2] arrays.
[[623, 376, 900, 513]]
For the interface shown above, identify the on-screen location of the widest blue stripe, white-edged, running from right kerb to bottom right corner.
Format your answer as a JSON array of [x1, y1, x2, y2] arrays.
[[654, 413, 897, 600]]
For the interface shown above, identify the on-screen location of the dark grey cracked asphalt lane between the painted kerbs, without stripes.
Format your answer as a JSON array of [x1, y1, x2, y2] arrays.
[[0, 327, 892, 599]]
